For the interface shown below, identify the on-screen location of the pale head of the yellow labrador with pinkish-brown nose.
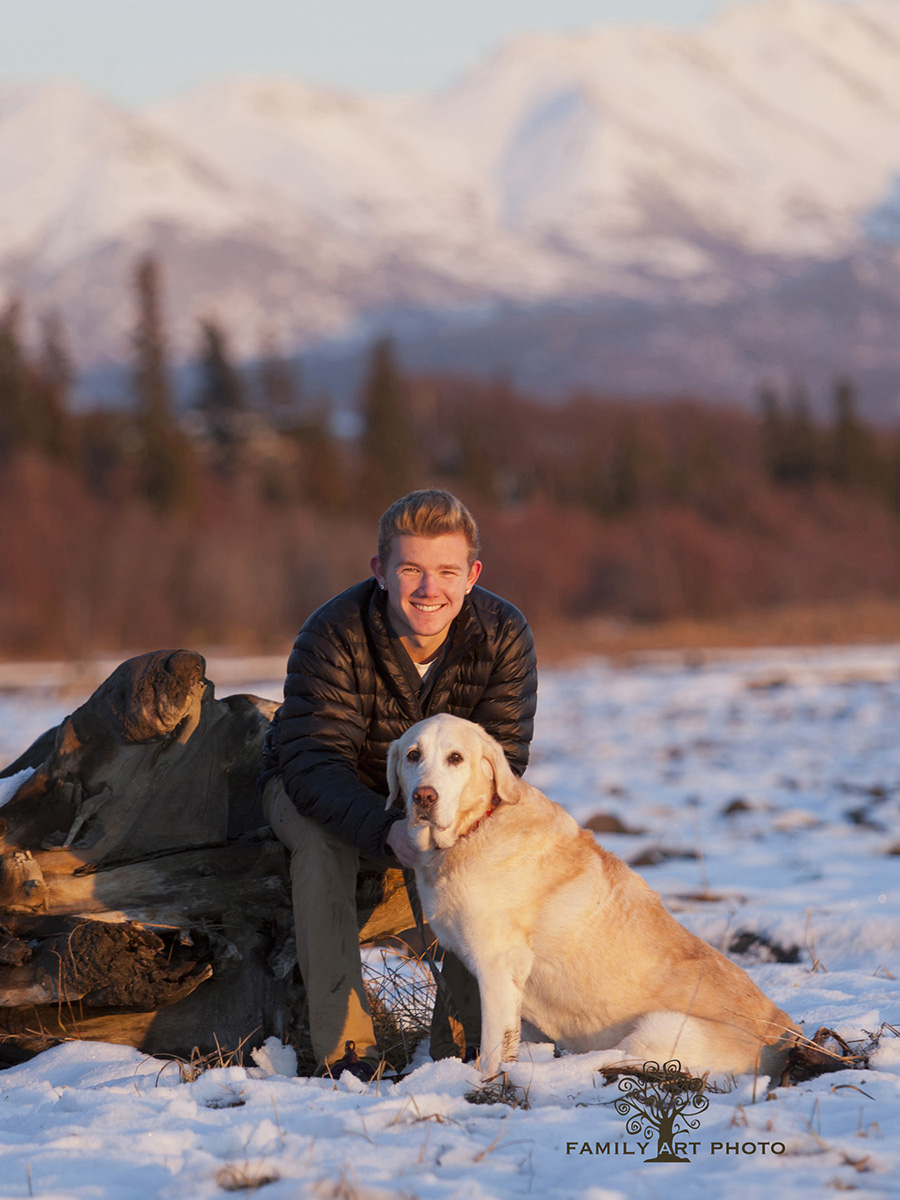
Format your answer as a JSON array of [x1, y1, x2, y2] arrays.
[[388, 713, 522, 851]]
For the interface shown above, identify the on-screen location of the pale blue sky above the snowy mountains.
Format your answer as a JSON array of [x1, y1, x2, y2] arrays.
[[0, 0, 728, 104]]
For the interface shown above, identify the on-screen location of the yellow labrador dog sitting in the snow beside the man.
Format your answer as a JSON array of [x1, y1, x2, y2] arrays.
[[388, 714, 800, 1075]]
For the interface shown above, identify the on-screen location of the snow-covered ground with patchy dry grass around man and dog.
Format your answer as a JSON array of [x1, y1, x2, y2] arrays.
[[0, 647, 900, 1200]]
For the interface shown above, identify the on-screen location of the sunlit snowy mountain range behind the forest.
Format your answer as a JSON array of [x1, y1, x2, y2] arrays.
[[0, 0, 900, 410]]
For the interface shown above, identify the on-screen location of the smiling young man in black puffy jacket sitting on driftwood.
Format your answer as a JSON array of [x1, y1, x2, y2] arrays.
[[263, 490, 538, 1076]]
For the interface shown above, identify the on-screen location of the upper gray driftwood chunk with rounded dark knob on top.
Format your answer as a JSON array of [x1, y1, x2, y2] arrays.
[[0, 650, 276, 865]]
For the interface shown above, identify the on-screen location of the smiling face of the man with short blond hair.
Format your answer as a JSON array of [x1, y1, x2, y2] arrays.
[[372, 533, 481, 662]]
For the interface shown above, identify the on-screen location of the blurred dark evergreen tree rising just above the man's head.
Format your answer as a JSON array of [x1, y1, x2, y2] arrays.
[[362, 337, 414, 502]]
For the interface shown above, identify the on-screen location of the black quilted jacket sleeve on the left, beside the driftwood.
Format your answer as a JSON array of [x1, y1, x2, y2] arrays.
[[278, 622, 400, 858]]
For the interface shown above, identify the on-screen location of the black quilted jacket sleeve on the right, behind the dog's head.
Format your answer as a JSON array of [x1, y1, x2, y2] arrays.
[[472, 605, 538, 775]]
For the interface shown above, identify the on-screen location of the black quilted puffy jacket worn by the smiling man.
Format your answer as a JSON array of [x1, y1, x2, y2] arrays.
[[270, 578, 538, 858]]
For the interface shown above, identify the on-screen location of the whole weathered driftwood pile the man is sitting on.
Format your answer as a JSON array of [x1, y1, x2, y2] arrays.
[[0, 650, 420, 1062]]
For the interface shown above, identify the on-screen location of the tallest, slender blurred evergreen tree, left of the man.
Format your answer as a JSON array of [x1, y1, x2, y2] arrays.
[[133, 256, 193, 509]]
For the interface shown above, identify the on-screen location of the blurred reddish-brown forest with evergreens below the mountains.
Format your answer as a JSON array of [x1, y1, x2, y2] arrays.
[[0, 259, 900, 658]]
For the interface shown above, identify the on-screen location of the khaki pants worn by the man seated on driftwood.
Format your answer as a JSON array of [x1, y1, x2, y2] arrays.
[[263, 776, 481, 1068]]
